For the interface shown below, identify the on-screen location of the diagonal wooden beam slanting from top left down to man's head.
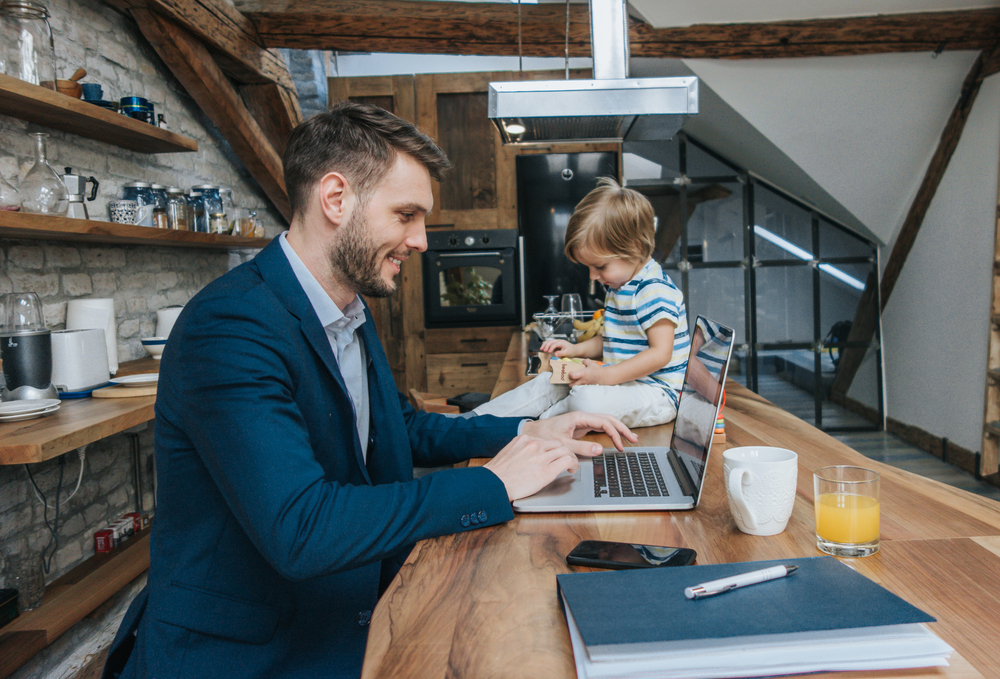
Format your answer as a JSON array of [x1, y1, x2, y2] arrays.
[[132, 9, 292, 220]]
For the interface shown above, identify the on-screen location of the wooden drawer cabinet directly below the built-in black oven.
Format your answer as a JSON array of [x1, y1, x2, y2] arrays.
[[424, 326, 518, 396]]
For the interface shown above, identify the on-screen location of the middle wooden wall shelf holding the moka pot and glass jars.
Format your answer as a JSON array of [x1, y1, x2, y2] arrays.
[[0, 211, 270, 250]]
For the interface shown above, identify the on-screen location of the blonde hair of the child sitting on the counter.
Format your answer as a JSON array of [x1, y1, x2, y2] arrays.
[[563, 177, 656, 262]]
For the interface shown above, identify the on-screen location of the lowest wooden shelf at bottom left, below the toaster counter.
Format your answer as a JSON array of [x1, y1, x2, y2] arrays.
[[0, 532, 149, 679]]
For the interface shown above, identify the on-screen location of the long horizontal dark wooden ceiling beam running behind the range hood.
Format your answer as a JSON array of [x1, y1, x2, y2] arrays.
[[236, 0, 1000, 59]]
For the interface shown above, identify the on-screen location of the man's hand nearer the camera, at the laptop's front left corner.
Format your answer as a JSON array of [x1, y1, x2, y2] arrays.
[[483, 434, 584, 502]]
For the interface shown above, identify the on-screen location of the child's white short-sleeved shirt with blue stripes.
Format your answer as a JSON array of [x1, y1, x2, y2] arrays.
[[604, 259, 691, 405]]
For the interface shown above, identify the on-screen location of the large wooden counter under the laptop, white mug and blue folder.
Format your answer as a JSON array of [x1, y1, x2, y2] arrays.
[[362, 334, 1000, 679]]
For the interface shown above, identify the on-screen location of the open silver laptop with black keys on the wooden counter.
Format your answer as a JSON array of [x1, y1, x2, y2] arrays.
[[514, 316, 734, 512]]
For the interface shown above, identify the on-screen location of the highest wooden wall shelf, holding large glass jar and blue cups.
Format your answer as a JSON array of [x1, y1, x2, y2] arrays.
[[0, 74, 198, 153]]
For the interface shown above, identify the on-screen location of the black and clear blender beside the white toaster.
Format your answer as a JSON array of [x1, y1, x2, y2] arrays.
[[0, 292, 59, 401]]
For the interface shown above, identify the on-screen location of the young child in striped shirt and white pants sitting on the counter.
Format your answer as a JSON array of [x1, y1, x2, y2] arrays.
[[474, 177, 690, 427]]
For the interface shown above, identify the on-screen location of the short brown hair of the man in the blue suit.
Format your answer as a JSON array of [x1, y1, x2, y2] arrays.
[[281, 101, 451, 214]]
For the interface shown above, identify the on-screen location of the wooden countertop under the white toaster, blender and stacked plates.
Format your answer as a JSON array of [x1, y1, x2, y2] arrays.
[[0, 358, 160, 464]]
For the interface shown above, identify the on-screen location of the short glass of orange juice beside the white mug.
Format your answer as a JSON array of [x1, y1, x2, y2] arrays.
[[813, 466, 879, 557]]
